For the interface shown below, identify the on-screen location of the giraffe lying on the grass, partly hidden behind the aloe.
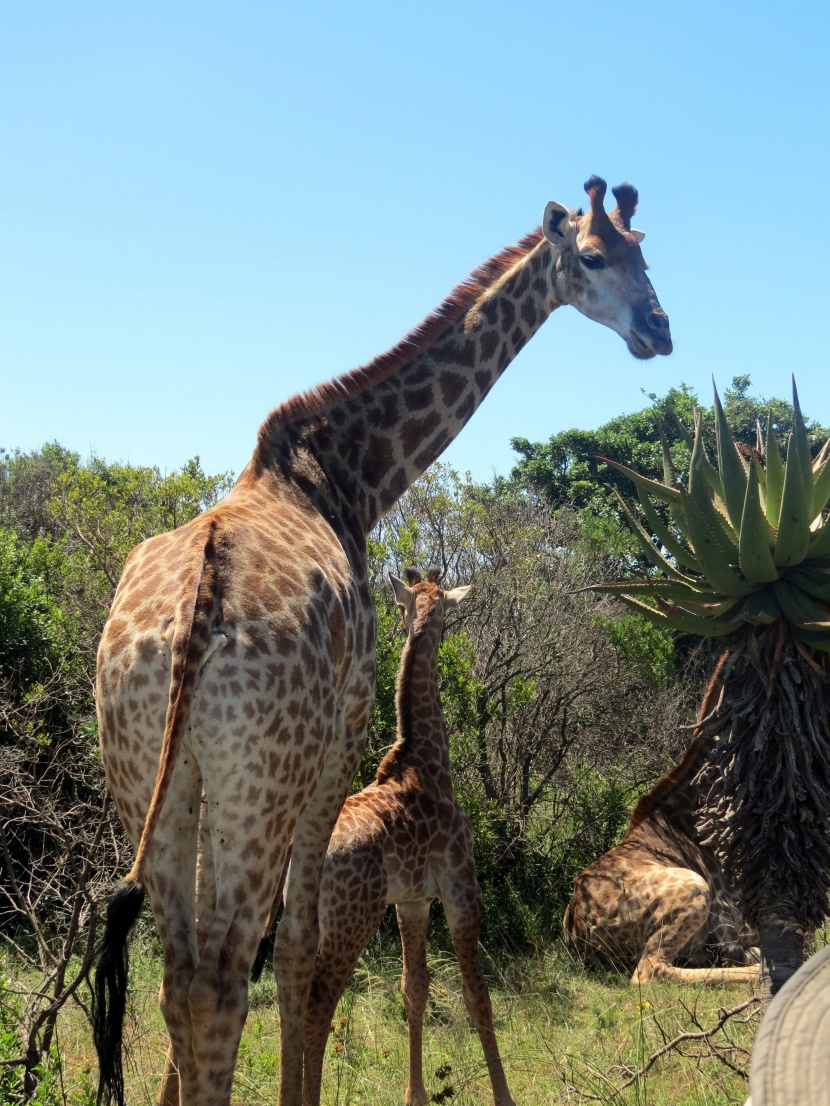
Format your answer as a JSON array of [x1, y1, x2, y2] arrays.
[[563, 655, 759, 984]]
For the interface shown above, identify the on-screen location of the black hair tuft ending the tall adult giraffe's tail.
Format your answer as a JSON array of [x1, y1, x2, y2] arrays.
[[92, 880, 144, 1106]]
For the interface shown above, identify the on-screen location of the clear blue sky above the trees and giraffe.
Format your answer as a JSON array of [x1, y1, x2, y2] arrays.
[[0, 0, 830, 479]]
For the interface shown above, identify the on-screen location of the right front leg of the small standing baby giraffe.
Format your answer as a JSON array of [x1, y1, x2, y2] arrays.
[[442, 869, 515, 1106]]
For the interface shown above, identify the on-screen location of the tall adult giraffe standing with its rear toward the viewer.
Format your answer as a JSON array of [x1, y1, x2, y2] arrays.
[[95, 177, 672, 1106]]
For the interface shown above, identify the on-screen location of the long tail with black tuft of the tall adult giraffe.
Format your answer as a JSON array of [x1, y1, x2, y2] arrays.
[[92, 522, 219, 1106]]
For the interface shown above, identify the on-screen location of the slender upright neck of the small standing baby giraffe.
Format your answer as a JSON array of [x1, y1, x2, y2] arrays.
[[377, 612, 452, 791]]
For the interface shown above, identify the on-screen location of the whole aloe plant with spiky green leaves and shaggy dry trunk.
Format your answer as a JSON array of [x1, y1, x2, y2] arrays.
[[593, 380, 830, 993]]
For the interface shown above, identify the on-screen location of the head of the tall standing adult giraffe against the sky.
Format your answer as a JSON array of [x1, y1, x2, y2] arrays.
[[542, 177, 672, 361]]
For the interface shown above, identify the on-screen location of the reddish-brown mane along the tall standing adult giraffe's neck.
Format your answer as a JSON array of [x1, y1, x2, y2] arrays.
[[255, 227, 542, 461]]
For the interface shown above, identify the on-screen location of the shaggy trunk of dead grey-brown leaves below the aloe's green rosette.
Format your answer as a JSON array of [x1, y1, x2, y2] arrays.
[[701, 619, 830, 997]]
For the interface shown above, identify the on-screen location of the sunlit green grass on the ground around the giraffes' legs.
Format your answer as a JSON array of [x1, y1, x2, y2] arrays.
[[1, 942, 757, 1106]]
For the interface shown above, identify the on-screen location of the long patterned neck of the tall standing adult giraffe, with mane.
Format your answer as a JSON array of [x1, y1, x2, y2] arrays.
[[253, 230, 568, 533]]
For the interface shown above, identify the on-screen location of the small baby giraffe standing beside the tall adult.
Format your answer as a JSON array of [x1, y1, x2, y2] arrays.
[[301, 570, 513, 1106]]
